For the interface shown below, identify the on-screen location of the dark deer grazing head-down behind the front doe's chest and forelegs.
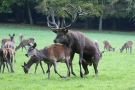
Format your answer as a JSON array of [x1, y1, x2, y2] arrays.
[[22, 56, 45, 74]]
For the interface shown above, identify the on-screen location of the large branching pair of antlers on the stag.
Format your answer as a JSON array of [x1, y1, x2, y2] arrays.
[[47, 4, 84, 30]]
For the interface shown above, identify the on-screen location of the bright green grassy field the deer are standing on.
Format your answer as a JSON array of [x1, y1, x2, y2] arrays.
[[0, 25, 135, 90]]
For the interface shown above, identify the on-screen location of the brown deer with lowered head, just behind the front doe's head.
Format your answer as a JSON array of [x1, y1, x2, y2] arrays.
[[15, 38, 35, 51]]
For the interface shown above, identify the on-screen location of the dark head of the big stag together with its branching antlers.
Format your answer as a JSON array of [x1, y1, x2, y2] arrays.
[[47, 4, 84, 43]]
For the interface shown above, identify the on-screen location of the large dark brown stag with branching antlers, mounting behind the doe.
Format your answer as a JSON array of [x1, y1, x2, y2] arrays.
[[47, 4, 100, 77]]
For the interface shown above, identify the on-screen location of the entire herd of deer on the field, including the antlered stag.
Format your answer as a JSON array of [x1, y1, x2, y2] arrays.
[[0, 4, 133, 79]]
